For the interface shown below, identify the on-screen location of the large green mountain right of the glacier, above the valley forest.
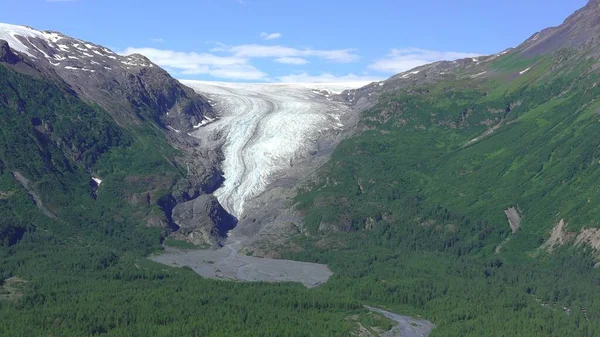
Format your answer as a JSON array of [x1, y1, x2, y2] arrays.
[[299, 1, 600, 255]]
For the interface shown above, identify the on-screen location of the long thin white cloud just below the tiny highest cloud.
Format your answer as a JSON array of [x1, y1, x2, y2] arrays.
[[220, 44, 359, 63]]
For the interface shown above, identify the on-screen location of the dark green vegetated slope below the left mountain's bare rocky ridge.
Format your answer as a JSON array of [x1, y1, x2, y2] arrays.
[[0, 60, 181, 248]]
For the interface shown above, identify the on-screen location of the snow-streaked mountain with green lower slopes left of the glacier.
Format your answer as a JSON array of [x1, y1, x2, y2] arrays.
[[0, 23, 225, 243]]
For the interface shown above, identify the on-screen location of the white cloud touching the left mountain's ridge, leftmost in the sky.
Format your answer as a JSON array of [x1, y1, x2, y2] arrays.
[[120, 48, 267, 80]]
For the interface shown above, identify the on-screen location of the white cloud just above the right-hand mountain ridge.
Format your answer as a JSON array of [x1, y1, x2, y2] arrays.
[[369, 48, 481, 73]]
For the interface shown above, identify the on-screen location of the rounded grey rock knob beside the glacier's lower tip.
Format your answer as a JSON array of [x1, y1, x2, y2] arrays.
[[172, 194, 236, 245]]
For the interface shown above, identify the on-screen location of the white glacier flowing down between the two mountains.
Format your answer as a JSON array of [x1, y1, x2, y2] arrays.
[[180, 80, 368, 219]]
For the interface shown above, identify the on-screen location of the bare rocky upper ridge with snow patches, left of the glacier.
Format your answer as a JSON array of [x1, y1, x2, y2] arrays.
[[0, 23, 214, 132]]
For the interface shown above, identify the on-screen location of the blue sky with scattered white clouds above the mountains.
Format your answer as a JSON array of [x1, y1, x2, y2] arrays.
[[0, 0, 586, 82]]
